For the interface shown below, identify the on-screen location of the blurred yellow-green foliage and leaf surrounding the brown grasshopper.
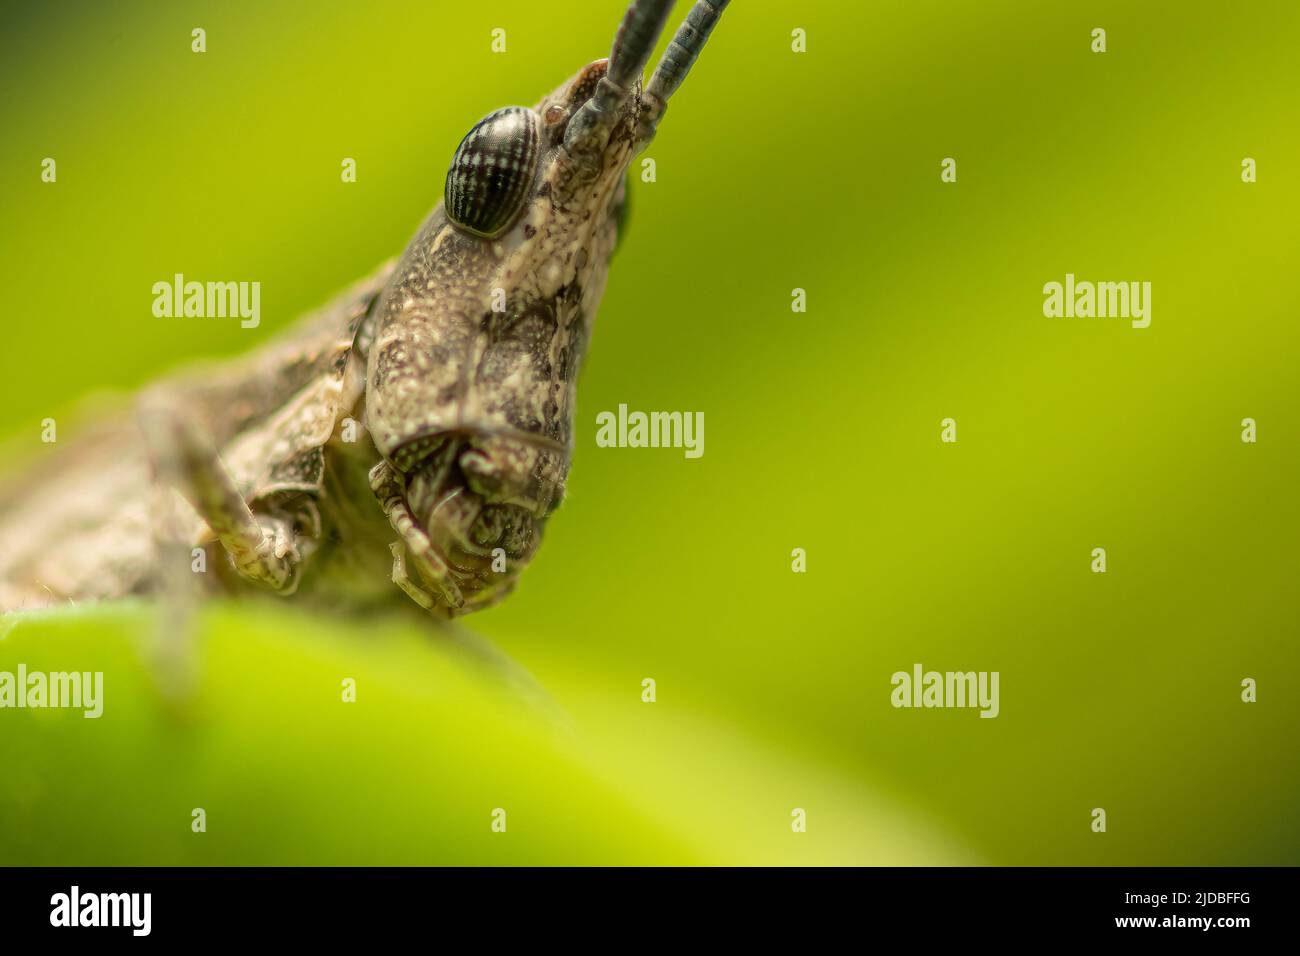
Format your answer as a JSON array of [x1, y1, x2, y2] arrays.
[[0, 0, 1300, 865]]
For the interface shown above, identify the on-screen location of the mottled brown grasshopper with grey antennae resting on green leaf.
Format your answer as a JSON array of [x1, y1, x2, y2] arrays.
[[0, 0, 728, 617]]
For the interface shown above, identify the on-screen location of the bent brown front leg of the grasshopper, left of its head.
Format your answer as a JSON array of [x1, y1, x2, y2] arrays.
[[142, 407, 311, 594]]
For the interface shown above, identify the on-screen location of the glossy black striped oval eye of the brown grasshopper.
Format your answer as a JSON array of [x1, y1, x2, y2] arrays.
[[443, 107, 540, 239]]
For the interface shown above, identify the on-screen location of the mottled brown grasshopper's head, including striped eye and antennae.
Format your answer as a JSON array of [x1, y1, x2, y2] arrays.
[[365, 0, 727, 613]]
